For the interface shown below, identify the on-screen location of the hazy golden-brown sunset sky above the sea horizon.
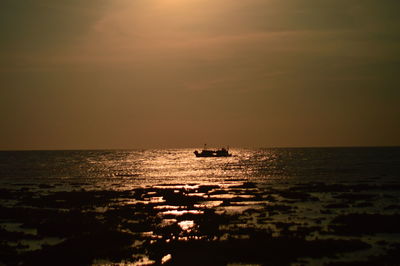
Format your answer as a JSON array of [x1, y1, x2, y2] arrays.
[[0, 0, 400, 150]]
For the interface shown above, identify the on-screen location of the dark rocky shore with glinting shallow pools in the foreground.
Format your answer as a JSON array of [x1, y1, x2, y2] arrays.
[[0, 179, 400, 265]]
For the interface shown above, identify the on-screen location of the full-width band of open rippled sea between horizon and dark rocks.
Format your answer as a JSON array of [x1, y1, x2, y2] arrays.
[[0, 147, 400, 189]]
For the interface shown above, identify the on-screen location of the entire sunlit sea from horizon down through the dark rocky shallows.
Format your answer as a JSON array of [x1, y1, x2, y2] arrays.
[[0, 147, 400, 265]]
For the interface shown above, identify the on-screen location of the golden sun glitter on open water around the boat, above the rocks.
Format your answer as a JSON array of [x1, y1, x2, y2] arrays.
[[91, 149, 278, 189]]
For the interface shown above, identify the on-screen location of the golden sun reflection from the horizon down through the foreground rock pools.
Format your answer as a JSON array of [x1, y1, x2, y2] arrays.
[[88, 149, 277, 265]]
